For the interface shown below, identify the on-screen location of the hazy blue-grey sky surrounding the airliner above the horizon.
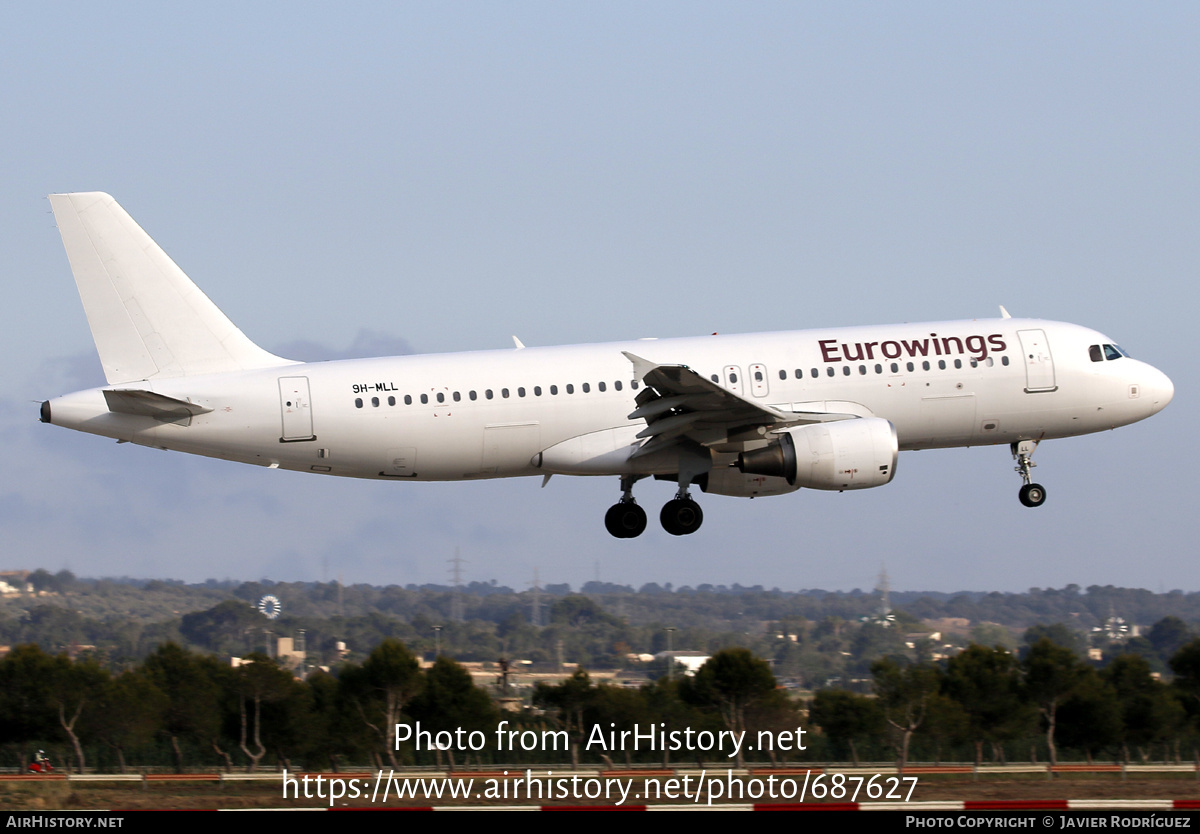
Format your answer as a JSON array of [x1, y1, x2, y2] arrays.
[[0, 2, 1200, 590]]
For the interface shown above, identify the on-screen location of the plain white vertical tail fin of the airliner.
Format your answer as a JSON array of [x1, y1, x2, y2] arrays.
[[50, 192, 293, 384]]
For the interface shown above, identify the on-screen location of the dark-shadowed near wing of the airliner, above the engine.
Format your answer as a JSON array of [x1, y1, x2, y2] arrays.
[[622, 350, 858, 457]]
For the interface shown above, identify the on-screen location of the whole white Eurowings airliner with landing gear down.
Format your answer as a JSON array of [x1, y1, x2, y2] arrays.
[[41, 193, 1175, 538]]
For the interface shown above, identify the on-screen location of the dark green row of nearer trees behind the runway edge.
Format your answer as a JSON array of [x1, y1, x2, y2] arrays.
[[7, 636, 1200, 773]]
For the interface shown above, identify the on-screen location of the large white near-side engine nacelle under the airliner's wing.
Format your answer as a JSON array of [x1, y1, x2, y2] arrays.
[[738, 418, 900, 491]]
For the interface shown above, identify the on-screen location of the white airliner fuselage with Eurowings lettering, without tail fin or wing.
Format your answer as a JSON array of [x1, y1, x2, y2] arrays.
[[43, 318, 1174, 489]]
